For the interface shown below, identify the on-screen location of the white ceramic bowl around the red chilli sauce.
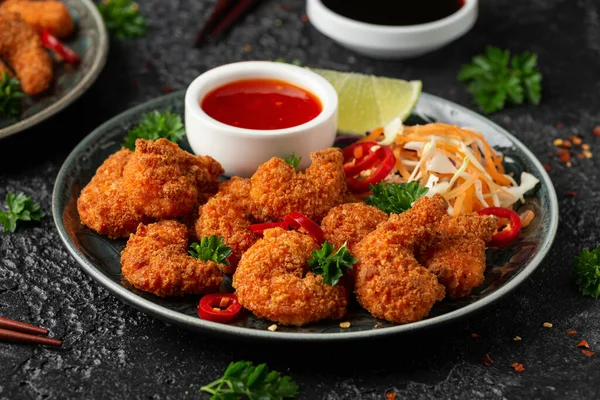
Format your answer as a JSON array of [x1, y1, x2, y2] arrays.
[[185, 61, 338, 177]]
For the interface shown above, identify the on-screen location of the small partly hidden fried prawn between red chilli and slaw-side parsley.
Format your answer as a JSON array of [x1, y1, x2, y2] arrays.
[[321, 203, 388, 252]]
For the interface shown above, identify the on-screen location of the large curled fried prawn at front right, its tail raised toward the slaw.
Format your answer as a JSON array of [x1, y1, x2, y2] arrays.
[[354, 195, 448, 323]]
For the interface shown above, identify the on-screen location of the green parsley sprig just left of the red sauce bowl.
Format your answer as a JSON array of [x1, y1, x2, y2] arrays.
[[123, 110, 185, 150]]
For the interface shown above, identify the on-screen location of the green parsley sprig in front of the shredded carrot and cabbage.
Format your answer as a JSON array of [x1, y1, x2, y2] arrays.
[[365, 182, 429, 214]]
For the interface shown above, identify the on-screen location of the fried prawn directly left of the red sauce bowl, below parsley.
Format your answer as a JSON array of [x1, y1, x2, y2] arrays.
[[123, 138, 223, 219]]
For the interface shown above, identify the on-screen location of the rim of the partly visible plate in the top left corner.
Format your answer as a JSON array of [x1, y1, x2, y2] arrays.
[[0, 0, 109, 139]]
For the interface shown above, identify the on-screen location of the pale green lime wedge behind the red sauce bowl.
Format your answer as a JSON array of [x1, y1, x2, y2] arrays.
[[312, 69, 423, 136]]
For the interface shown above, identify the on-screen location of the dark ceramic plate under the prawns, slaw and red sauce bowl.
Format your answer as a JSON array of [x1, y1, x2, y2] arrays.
[[52, 92, 558, 341]]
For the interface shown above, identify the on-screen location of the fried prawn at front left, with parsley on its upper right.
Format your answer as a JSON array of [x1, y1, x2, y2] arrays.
[[121, 220, 223, 297]]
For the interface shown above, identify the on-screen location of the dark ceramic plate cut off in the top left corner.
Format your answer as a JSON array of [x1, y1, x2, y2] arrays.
[[0, 0, 108, 139]]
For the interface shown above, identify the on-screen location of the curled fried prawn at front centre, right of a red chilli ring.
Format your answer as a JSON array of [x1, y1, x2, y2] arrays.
[[233, 228, 348, 326]]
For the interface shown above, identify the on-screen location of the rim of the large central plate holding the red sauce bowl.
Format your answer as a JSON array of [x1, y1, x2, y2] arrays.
[[52, 90, 559, 342]]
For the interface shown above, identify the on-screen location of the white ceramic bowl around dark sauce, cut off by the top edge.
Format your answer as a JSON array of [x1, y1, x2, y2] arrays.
[[306, 0, 478, 59]]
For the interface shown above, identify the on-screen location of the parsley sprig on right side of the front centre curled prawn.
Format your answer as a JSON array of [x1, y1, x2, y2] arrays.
[[308, 242, 358, 286]]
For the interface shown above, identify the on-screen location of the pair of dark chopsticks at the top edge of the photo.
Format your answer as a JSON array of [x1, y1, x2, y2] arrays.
[[194, 0, 259, 47]]
